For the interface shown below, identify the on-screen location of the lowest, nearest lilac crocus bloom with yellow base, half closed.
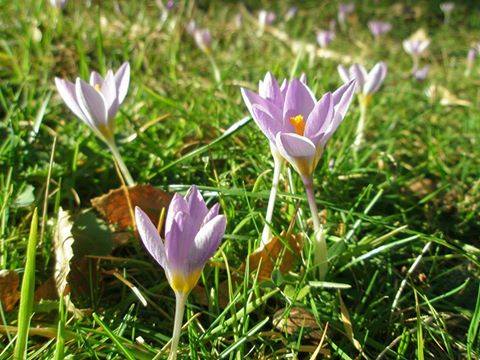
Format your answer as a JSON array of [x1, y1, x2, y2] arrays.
[[135, 186, 226, 295]]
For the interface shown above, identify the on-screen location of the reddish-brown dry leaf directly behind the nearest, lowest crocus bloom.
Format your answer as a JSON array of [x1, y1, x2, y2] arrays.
[[91, 185, 172, 230]]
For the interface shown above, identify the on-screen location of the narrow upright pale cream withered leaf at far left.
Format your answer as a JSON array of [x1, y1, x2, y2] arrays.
[[53, 208, 74, 296]]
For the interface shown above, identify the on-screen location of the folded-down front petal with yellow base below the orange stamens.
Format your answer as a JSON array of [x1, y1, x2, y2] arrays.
[[276, 133, 316, 176]]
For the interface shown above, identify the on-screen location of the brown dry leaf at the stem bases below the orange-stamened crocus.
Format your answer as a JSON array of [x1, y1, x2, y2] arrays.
[[243, 231, 303, 280]]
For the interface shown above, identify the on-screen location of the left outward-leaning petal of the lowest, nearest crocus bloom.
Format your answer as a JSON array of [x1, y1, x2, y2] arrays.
[[135, 206, 167, 269]]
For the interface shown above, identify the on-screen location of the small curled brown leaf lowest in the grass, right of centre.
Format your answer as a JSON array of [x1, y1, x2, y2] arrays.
[[272, 307, 322, 340]]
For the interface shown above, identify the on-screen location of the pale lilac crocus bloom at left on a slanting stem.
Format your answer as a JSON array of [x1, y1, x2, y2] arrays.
[[55, 62, 130, 143]]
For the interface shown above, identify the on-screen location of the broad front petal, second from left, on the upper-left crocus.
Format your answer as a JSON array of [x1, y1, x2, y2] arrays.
[[75, 79, 108, 128]]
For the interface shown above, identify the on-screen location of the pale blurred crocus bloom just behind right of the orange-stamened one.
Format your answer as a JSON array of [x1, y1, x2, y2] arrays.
[[337, 61, 387, 97]]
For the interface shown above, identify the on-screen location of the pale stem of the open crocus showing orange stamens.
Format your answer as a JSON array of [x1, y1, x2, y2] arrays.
[[302, 176, 328, 280]]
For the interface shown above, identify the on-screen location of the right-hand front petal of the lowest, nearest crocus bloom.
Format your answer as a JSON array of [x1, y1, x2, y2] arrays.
[[189, 215, 227, 271]]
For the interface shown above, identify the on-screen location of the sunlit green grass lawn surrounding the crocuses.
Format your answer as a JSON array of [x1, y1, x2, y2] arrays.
[[0, 0, 480, 359]]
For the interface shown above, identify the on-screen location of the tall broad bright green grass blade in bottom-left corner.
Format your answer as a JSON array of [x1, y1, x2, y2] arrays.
[[13, 208, 38, 360]]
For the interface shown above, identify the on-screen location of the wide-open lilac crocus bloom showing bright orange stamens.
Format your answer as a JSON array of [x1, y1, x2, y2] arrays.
[[242, 73, 355, 176]]
